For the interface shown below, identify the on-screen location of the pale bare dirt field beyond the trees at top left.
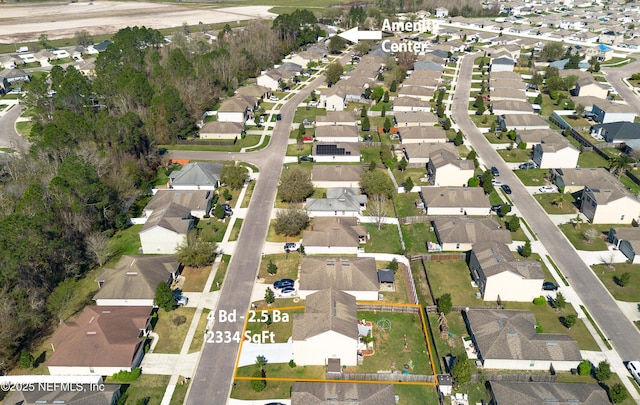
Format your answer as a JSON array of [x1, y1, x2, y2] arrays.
[[0, 0, 276, 43]]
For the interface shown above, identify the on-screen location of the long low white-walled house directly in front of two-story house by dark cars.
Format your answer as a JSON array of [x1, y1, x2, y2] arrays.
[[420, 187, 491, 215]]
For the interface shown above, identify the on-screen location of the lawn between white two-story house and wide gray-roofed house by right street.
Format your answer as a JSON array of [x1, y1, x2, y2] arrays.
[[504, 302, 600, 351]]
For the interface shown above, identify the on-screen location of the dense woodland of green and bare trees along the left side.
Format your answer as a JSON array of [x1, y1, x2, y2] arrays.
[[0, 12, 319, 373]]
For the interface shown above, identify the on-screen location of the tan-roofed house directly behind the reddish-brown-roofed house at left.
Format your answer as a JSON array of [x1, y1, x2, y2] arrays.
[[93, 255, 182, 307]]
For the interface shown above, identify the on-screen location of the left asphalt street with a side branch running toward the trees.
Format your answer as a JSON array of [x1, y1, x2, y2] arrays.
[[180, 72, 324, 405]]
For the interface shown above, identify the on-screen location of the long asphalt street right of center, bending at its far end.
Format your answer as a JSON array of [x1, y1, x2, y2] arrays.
[[452, 55, 640, 361]]
